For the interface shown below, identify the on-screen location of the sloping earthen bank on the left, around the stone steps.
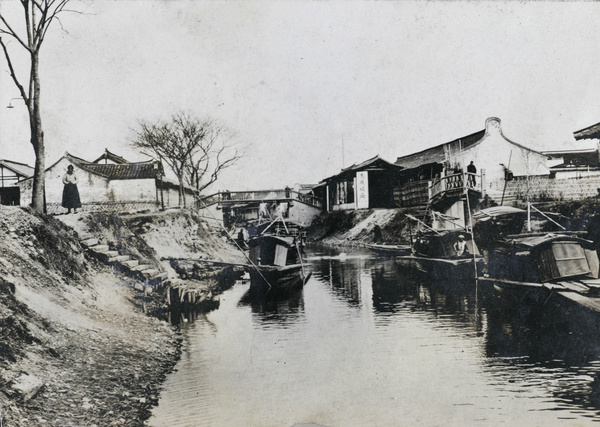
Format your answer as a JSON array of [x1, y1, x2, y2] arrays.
[[0, 206, 244, 427]]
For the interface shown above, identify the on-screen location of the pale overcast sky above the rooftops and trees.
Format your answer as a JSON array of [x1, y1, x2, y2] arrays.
[[0, 0, 600, 191]]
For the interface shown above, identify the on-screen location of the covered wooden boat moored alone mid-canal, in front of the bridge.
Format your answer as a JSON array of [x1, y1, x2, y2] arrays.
[[248, 229, 308, 294]]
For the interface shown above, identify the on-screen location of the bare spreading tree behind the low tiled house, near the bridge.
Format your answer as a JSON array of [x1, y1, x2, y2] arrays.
[[133, 112, 240, 206]]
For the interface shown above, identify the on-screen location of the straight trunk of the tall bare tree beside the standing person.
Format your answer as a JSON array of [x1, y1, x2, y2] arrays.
[[27, 51, 46, 212]]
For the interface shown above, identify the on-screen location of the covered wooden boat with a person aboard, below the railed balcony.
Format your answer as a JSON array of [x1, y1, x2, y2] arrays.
[[396, 229, 484, 282]]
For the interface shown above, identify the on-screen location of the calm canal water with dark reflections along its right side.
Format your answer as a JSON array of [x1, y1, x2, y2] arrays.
[[149, 247, 600, 427]]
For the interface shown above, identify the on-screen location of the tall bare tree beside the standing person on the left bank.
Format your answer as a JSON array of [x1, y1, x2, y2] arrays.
[[0, 0, 74, 212]]
